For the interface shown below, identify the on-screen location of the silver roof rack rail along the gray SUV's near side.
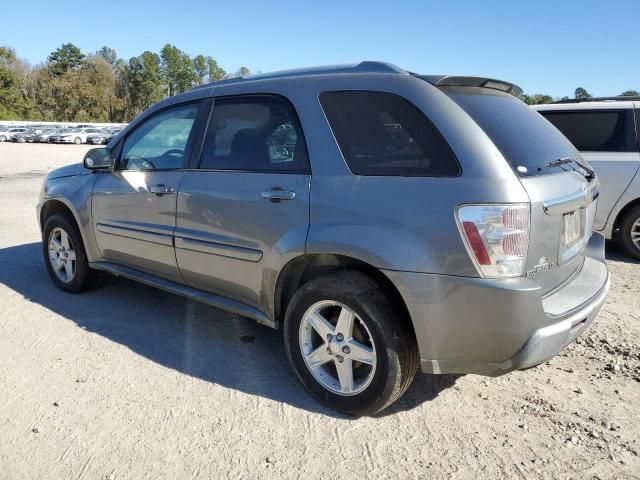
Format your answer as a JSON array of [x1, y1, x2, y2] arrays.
[[194, 60, 408, 90]]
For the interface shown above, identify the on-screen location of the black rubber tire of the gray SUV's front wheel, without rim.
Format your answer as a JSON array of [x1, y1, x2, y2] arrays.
[[42, 214, 102, 293]]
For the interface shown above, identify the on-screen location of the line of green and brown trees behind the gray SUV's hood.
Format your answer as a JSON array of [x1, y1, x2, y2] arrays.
[[0, 43, 250, 123]]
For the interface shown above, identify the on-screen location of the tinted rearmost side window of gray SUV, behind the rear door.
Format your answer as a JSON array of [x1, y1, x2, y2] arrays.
[[320, 91, 460, 177]]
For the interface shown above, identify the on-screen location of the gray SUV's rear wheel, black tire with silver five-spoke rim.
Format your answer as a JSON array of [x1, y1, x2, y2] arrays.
[[284, 270, 419, 416]]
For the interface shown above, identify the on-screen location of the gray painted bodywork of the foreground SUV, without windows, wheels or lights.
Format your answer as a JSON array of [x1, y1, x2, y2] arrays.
[[38, 62, 609, 375]]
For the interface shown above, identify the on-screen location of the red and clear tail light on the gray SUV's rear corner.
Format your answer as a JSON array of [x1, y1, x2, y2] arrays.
[[456, 204, 529, 278]]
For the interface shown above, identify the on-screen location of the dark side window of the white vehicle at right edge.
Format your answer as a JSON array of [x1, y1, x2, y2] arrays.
[[540, 109, 638, 152]]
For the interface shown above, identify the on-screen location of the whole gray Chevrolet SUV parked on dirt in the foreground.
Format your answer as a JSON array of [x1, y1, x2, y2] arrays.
[[38, 62, 609, 415]]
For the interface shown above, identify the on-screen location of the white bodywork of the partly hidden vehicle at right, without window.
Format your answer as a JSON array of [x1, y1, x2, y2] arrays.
[[533, 100, 640, 239]]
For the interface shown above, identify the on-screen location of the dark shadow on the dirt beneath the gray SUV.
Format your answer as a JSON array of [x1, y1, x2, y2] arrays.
[[0, 242, 455, 419]]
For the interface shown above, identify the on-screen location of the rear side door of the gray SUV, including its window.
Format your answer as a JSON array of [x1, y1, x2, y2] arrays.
[[175, 95, 310, 308]]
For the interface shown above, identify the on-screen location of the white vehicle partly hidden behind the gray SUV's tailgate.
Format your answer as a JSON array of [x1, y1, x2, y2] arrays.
[[535, 97, 640, 260]]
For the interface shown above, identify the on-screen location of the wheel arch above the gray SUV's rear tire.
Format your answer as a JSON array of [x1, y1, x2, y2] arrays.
[[273, 253, 413, 330]]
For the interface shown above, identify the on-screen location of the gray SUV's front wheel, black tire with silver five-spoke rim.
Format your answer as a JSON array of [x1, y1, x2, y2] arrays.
[[42, 214, 101, 293]]
